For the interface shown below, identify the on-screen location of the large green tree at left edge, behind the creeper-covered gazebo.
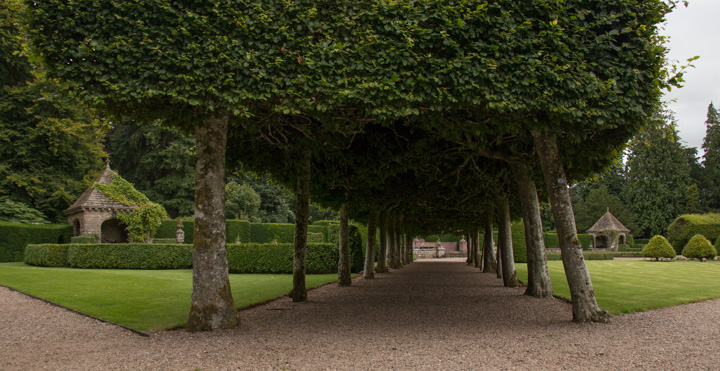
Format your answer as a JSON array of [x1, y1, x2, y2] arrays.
[[0, 1, 106, 222]]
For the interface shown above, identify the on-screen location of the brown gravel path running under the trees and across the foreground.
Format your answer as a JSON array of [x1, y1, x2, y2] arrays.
[[0, 259, 720, 370]]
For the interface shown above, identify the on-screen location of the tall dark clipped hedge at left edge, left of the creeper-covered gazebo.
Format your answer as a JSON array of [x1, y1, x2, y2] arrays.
[[0, 222, 72, 262]]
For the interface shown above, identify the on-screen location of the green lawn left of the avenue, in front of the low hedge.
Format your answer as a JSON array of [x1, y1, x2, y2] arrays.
[[0, 263, 344, 331]]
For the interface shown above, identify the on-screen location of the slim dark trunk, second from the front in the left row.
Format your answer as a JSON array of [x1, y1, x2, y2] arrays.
[[288, 149, 311, 302]]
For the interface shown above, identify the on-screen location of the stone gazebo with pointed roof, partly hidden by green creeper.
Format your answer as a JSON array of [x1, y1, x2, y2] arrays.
[[63, 163, 137, 243]]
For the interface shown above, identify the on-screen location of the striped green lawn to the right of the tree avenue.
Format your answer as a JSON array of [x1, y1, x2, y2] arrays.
[[516, 260, 720, 314]]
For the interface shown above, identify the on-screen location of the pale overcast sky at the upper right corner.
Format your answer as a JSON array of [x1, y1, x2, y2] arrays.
[[663, 0, 720, 153]]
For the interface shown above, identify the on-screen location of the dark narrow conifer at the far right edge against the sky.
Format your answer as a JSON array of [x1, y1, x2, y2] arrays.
[[701, 103, 720, 210]]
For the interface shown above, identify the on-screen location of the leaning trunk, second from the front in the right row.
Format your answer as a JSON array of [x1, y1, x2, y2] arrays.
[[513, 165, 553, 298]]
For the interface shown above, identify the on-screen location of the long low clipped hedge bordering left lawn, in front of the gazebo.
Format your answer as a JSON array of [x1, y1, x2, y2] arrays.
[[25, 243, 338, 274]]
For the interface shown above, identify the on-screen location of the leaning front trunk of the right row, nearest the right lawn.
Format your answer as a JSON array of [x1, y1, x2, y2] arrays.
[[532, 131, 609, 322]]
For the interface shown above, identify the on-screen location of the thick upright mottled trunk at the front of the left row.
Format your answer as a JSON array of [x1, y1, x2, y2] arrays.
[[186, 116, 238, 332]]
